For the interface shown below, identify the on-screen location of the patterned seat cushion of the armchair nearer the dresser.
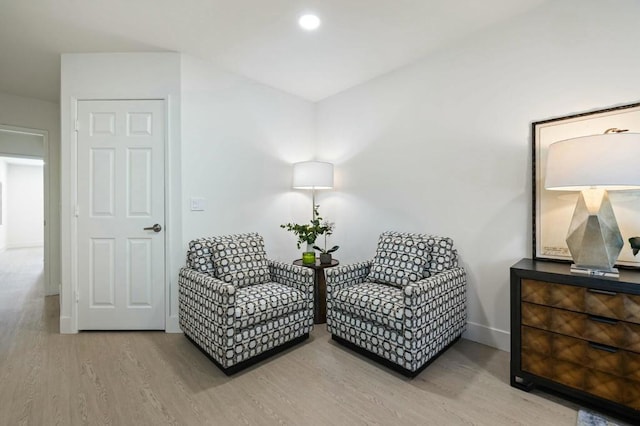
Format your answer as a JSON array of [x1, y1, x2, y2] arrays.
[[332, 282, 404, 331]]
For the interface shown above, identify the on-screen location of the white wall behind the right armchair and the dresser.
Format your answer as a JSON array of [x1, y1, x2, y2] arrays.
[[317, 0, 640, 350]]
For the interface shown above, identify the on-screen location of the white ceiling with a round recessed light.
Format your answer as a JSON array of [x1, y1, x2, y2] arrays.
[[0, 0, 549, 101]]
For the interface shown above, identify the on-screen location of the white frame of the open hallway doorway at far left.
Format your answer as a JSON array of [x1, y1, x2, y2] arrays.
[[0, 124, 50, 296]]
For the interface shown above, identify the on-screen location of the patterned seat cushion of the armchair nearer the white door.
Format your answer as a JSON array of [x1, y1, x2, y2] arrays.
[[234, 282, 308, 329]]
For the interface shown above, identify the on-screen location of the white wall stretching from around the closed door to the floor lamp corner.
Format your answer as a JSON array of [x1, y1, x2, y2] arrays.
[[60, 53, 314, 333]]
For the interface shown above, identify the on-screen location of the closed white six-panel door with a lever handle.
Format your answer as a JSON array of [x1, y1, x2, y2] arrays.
[[76, 100, 165, 330]]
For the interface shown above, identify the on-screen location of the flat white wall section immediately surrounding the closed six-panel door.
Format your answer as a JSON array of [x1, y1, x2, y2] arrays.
[[60, 53, 184, 333]]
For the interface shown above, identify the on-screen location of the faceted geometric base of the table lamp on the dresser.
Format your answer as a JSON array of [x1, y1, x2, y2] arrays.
[[567, 189, 624, 276]]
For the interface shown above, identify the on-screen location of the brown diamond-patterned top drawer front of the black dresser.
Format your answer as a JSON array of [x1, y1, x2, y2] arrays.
[[521, 279, 640, 324]]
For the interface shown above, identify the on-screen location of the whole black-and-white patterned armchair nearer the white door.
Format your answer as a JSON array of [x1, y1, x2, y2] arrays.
[[178, 233, 313, 375]]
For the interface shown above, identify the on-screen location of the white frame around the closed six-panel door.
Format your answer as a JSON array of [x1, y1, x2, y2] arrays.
[[68, 96, 172, 333]]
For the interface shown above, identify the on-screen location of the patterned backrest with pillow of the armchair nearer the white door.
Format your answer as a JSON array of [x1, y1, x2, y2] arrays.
[[189, 233, 271, 287]]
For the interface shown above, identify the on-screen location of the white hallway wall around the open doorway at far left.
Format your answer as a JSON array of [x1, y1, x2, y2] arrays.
[[0, 93, 61, 295]]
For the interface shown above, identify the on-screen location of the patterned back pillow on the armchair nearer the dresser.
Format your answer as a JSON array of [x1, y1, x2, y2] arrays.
[[367, 233, 428, 287]]
